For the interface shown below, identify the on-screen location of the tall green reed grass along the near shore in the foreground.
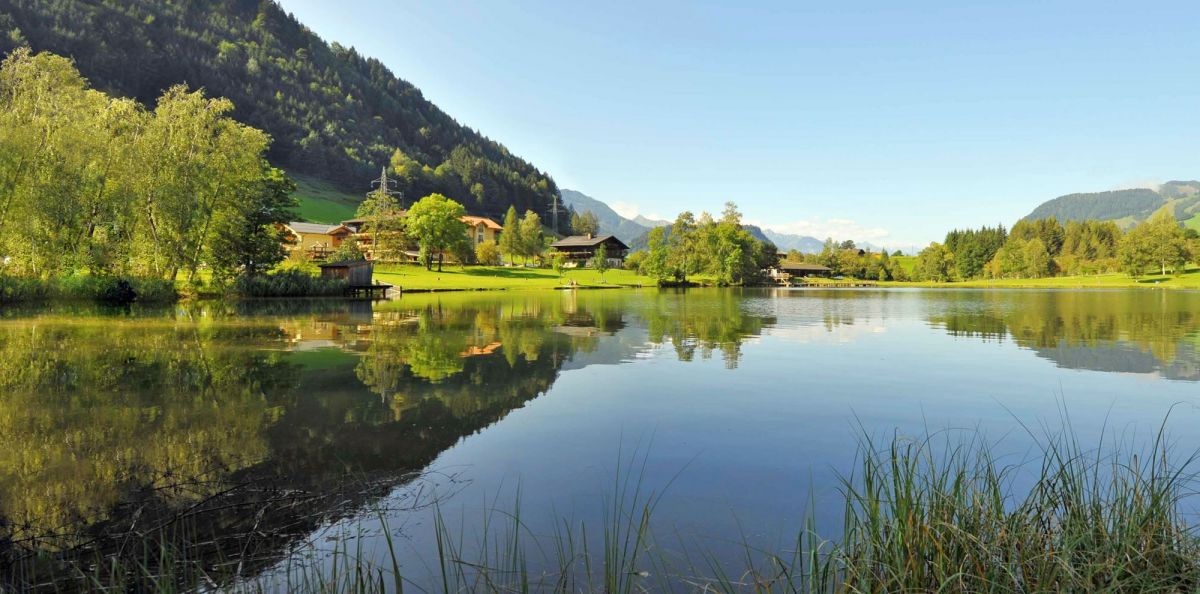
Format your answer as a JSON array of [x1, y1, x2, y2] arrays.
[[9, 420, 1200, 594]]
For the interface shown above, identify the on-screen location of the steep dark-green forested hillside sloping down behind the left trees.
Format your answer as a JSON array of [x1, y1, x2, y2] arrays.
[[0, 0, 558, 215]]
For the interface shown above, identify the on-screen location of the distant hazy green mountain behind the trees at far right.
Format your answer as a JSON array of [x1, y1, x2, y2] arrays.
[[1025, 181, 1200, 228]]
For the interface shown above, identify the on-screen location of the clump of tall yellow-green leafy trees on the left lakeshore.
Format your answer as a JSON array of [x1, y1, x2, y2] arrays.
[[0, 49, 295, 300]]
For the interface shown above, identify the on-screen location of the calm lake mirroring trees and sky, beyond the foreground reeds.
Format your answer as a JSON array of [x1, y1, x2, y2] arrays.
[[0, 289, 1200, 587]]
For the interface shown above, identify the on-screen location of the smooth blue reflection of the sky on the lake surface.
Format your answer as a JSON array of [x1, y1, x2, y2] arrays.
[[295, 293, 1200, 590]]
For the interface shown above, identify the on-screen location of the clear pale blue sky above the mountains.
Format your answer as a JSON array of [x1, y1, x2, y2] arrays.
[[274, 0, 1200, 246]]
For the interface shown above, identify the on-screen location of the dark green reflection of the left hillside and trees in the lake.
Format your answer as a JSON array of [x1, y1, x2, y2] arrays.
[[0, 292, 763, 586]]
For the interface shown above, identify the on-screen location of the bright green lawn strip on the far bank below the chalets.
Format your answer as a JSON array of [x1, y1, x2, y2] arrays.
[[374, 264, 655, 290]]
